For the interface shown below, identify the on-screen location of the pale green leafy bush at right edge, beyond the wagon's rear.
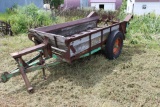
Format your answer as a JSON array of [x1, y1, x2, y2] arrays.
[[127, 13, 160, 39]]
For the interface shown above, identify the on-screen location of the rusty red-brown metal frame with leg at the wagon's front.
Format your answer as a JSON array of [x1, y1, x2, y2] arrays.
[[11, 38, 52, 92]]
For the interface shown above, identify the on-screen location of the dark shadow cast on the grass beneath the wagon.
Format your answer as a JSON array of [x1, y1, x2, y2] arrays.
[[9, 46, 145, 93]]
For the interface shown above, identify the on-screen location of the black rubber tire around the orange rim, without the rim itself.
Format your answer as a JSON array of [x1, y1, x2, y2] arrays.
[[104, 30, 123, 60]]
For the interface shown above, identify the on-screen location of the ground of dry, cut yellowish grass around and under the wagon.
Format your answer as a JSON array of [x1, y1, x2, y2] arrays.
[[0, 36, 160, 107]]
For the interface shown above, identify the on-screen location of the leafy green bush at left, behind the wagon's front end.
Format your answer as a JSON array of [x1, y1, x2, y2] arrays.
[[8, 4, 53, 34]]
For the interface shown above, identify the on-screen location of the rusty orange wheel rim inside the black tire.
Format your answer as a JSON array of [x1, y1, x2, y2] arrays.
[[113, 38, 122, 55]]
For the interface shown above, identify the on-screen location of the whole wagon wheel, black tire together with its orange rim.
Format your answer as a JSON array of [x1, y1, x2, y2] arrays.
[[105, 31, 123, 60]]
